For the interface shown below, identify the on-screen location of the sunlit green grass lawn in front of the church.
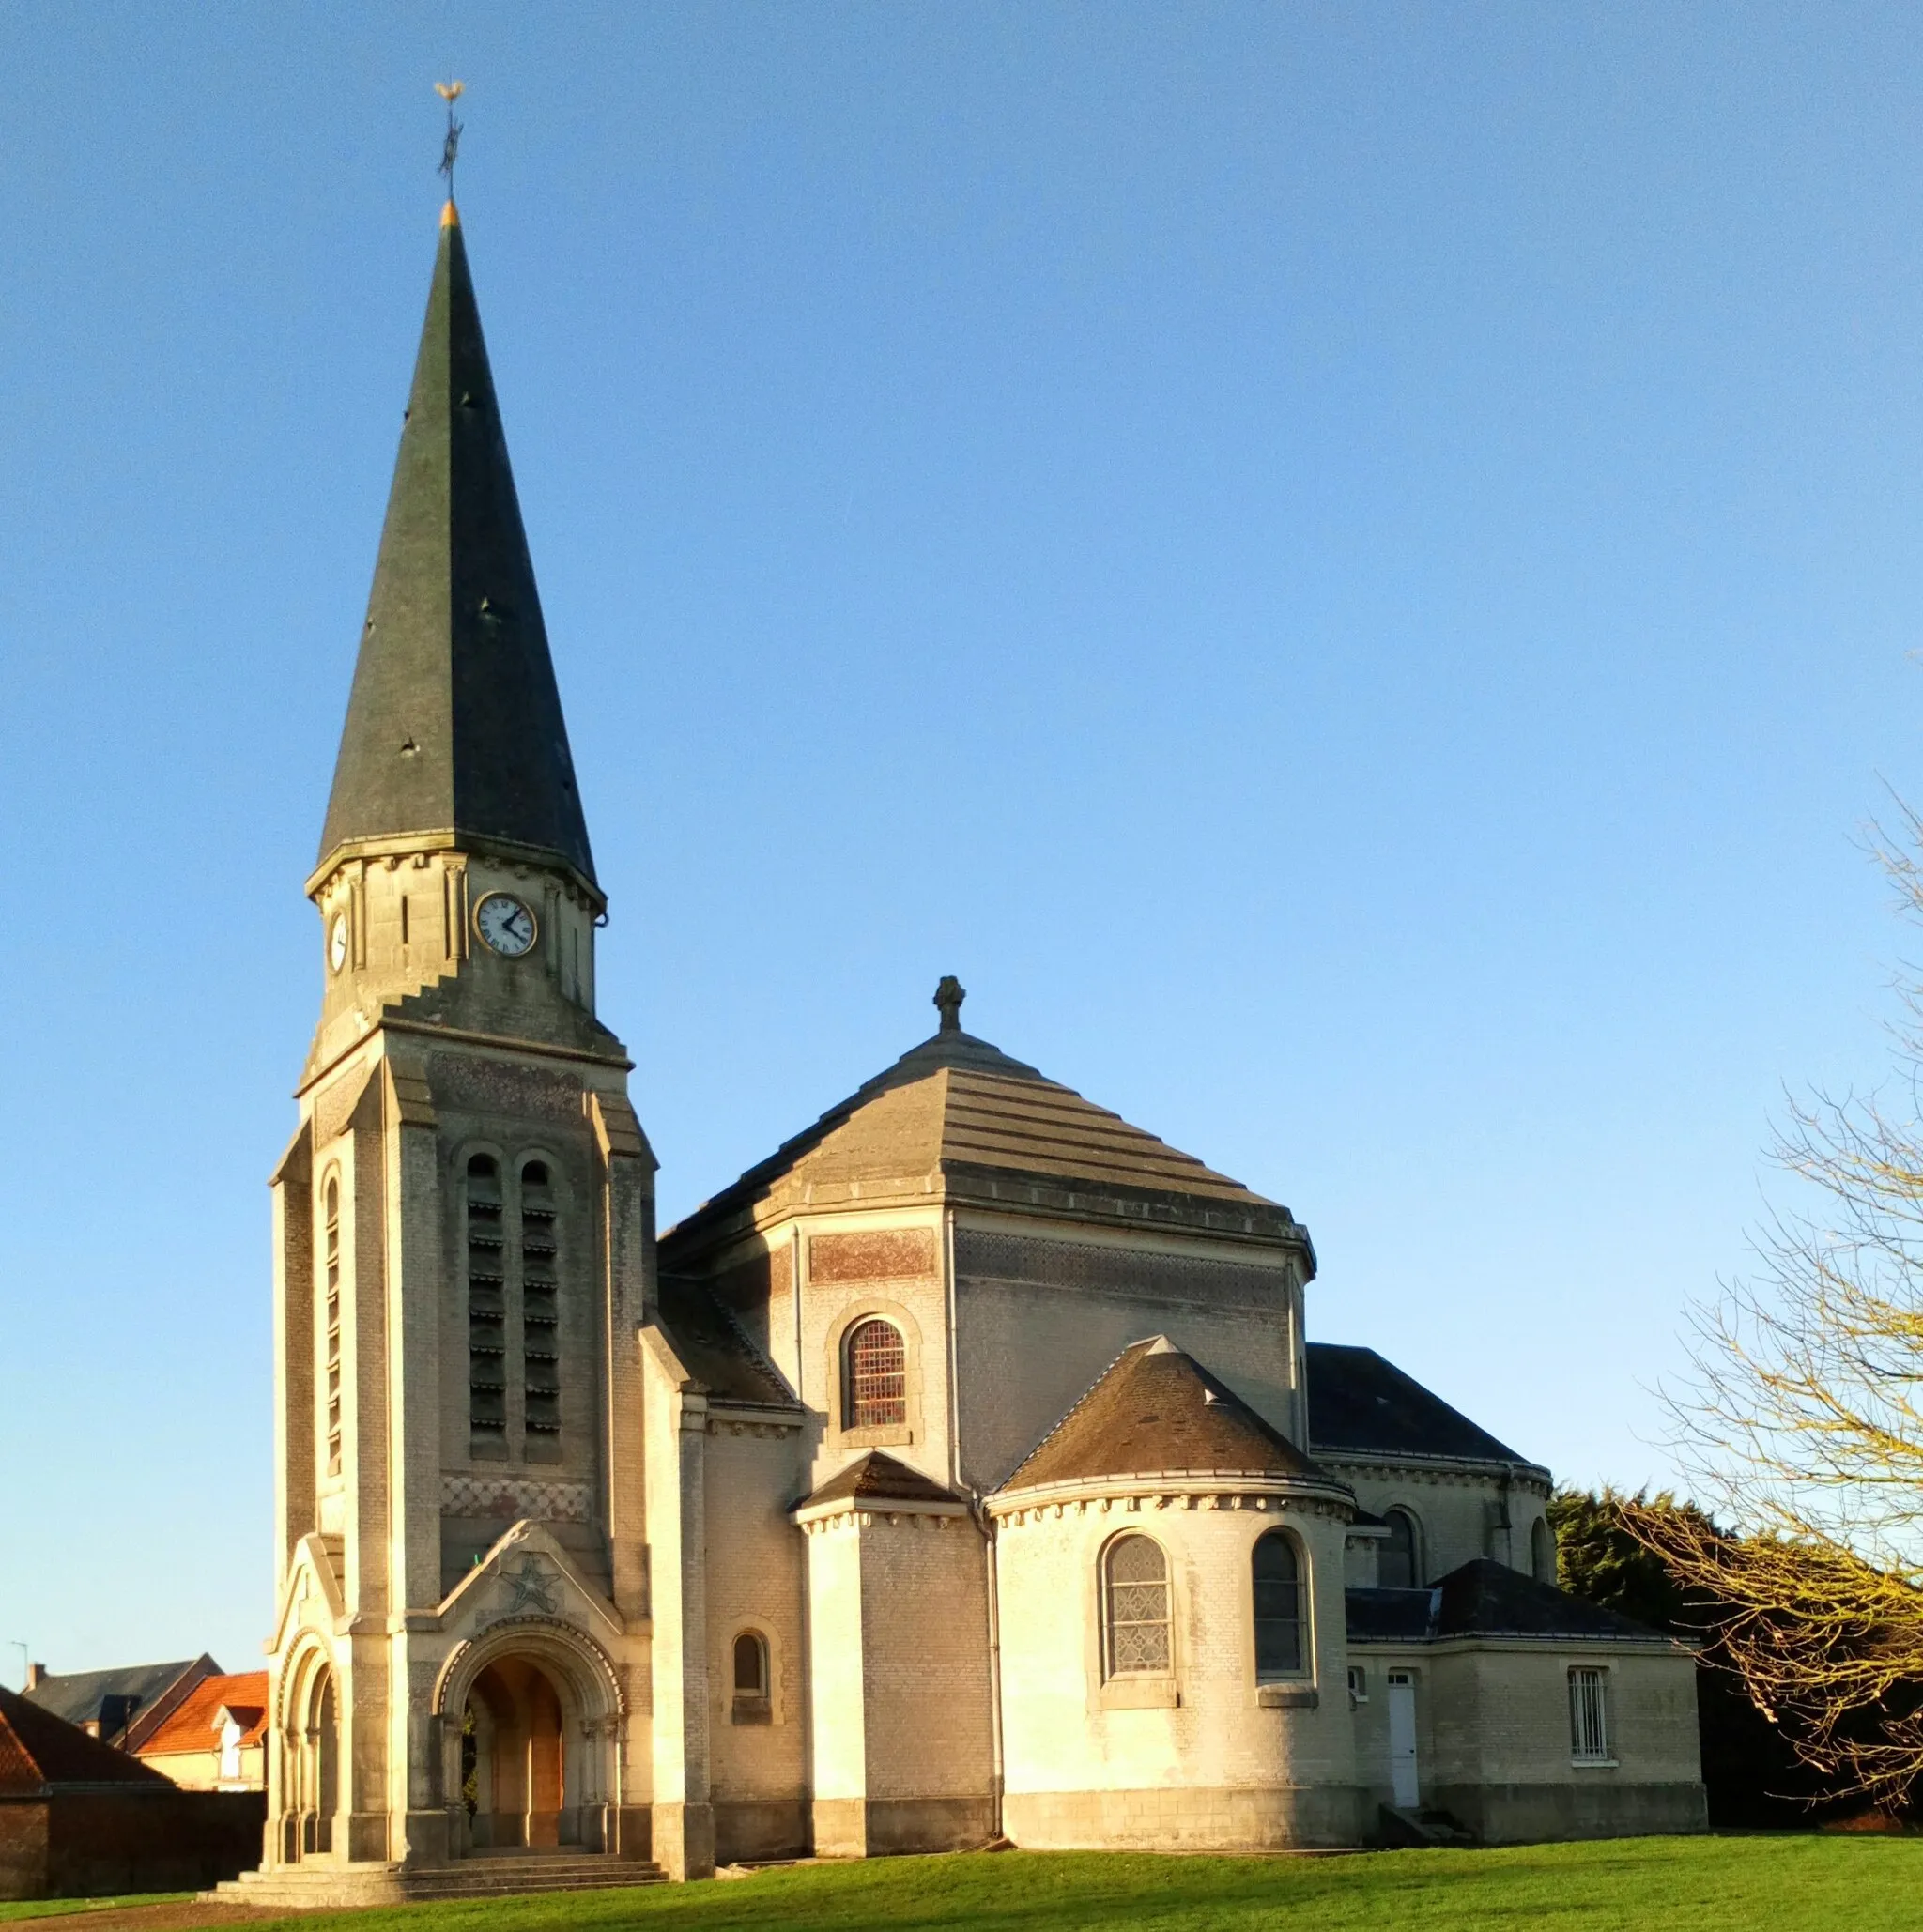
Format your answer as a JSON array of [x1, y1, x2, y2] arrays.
[[262, 1837, 1923, 1932]]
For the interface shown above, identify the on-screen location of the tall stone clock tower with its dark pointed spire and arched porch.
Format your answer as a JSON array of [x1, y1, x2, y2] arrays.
[[267, 203, 683, 1878]]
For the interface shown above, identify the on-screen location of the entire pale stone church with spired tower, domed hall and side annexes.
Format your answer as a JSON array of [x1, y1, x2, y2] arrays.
[[240, 205, 1702, 1899]]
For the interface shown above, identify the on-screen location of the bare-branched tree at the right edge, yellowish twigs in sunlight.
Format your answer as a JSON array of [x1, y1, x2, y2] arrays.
[[1627, 807, 1923, 1799]]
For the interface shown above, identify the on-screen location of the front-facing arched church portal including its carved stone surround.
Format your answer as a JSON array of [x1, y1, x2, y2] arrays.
[[433, 1618, 624, 1857]]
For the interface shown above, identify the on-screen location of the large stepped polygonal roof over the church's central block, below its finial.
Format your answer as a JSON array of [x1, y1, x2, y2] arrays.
[[663, 1028, 1306, 1254]]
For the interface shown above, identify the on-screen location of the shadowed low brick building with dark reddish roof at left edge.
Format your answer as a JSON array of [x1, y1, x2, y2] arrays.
[[0, 1689, 267, 1899]]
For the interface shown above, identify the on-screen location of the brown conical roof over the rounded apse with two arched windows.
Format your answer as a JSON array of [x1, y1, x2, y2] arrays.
[[997, 1335, 1335, 1495]]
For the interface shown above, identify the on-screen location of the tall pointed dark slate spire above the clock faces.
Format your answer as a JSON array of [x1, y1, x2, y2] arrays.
[[321, 201, 593, 885]]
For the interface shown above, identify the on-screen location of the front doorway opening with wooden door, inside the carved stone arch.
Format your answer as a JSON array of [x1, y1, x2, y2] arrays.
[[460, 1658, 582, 1851]]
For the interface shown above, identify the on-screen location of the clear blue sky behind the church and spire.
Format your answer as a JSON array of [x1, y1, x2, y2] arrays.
[[0, 0, 1923, 1683]]
